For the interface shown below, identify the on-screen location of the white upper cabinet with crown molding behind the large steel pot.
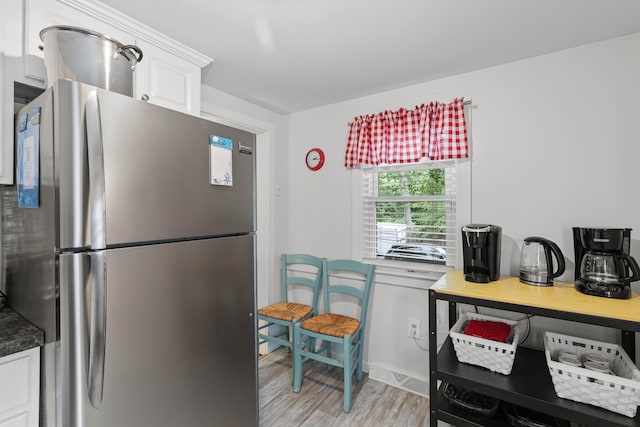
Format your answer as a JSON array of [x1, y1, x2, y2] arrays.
[[22, 0, 211, 115]]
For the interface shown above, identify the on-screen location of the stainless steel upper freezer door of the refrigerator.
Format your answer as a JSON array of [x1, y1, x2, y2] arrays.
[[54, 80, 255, 249]]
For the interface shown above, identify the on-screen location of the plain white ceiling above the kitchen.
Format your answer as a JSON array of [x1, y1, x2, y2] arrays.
[[102, 0, 640, 113]]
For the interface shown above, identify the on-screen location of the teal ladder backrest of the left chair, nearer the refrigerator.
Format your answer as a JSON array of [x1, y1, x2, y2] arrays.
[[281, 254, 322, 313]]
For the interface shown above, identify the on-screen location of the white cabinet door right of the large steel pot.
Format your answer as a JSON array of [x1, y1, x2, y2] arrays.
[[136, 40, 200, 116]]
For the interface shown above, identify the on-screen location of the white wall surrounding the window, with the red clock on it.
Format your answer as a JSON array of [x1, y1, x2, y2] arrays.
[[274, 33, 640, 378]]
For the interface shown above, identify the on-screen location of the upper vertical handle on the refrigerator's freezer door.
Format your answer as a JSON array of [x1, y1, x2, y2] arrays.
[[85, 90, 107, 250]]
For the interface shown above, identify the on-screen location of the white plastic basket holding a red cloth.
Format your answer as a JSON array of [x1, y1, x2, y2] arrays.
[[449, 313, 520, 375]]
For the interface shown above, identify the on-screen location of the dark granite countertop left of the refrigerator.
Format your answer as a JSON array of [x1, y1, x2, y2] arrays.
[[0, 307, 44, 357]]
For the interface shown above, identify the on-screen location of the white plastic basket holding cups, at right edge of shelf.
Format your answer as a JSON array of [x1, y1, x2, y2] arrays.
[[544, 332, 640, 417]]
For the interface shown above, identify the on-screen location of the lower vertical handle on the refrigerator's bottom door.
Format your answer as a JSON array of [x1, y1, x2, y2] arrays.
[[87, 251, 107, 408]]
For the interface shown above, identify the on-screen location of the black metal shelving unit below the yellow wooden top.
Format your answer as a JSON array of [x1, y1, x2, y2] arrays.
[[429, 274, 640, 427]]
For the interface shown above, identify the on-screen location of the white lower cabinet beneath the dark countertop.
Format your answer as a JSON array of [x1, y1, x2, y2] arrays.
[[0, 347, 40, 427]]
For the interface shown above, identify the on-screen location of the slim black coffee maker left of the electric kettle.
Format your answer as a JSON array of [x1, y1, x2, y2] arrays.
[[462, 224, 502, 283]]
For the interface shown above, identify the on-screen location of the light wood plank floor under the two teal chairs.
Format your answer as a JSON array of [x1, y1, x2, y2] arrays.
[[258, 349, 429, 427]]
